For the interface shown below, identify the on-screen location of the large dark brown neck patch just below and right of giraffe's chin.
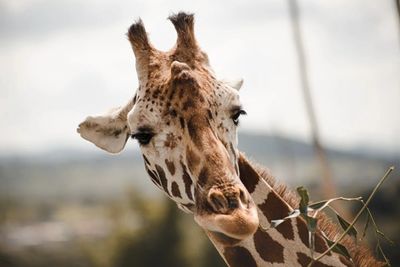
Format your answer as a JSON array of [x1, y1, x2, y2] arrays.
[[254, 229, 284, 263]]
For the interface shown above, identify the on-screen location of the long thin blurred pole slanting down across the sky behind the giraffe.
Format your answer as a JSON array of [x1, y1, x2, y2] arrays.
[[288, 0, 336, 201]]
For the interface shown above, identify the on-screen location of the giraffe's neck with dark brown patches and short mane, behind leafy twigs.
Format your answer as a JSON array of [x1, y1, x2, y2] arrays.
[[207, 154, 383, 267]]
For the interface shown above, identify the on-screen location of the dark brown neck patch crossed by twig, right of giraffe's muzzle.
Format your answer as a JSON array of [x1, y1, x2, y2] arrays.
[[258, 191, 294, 240]]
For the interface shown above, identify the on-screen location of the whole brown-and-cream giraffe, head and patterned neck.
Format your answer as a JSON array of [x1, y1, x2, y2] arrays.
[[77, 12, 383, 267]]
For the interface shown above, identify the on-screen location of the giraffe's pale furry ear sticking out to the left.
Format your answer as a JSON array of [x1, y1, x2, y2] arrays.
[[77, 97, 133, 153]]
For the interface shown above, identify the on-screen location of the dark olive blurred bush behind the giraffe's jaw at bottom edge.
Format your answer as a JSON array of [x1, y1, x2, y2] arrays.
[[85, 192, 225, 267]]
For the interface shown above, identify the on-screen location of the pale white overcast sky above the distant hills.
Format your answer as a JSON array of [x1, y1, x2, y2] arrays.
[[0, 0, 400, 154]]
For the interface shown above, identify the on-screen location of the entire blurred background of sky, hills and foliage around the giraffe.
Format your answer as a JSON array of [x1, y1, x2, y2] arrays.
[[0, 0, 400, 267]]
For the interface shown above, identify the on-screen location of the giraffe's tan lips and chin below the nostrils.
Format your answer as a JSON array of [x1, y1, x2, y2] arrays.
[[194, 204, 259, 246]]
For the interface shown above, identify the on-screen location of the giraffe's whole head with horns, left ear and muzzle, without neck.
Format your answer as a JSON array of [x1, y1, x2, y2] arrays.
[[78, 13, 259, 244]]
